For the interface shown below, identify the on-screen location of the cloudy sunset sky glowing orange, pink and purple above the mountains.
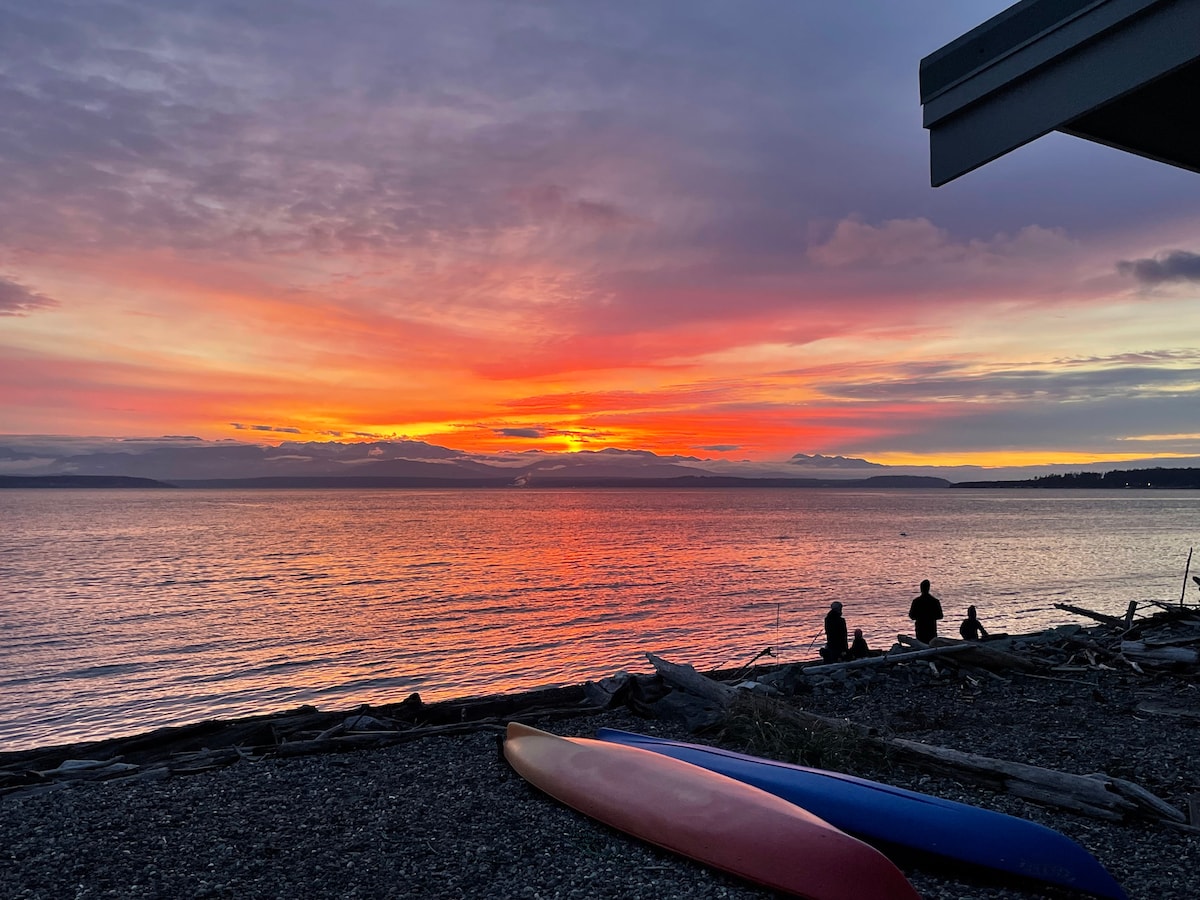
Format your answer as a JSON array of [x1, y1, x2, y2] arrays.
[[0, 0, 1200, 464]]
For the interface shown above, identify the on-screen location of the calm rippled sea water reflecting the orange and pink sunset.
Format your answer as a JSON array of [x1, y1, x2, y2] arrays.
[[0, 490, 1200, 750]]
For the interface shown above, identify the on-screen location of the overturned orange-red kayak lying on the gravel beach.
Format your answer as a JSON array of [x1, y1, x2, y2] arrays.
[[504, 722, 920, 900]]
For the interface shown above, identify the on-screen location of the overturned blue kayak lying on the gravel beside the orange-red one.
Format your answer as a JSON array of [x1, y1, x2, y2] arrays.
[[596, 728, 1128, 900]]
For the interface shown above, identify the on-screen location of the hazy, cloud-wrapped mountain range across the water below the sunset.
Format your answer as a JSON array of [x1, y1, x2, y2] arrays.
[[0, 436, 1200, 487]]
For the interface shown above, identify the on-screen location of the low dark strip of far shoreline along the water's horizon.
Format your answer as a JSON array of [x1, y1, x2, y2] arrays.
[[0, 468, 1200, 491]]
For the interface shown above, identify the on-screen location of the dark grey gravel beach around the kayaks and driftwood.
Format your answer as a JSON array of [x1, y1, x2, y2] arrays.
[[0, 666, 1200, 900]]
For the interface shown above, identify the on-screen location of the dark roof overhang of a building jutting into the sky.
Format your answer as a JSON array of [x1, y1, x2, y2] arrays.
[[920, 0, 1200, 187]]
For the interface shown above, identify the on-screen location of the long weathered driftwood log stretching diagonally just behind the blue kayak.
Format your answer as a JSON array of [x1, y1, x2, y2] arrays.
[[647, 648, 1187, 826]]
